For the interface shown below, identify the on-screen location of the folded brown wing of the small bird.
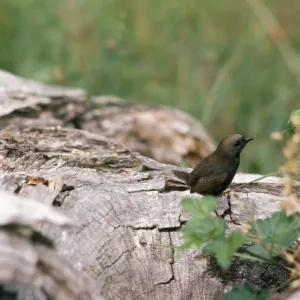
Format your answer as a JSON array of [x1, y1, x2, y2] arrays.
[[191, 172, 227, 194]]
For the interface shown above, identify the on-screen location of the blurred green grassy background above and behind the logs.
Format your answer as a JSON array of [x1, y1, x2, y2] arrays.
[[0, 0, 300, 173]]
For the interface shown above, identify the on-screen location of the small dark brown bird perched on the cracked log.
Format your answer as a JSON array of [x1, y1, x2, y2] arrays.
[[176, 134, 253, 196]]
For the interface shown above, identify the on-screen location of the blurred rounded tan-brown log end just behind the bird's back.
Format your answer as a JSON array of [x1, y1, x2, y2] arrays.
[[78, 96, 214, 166]]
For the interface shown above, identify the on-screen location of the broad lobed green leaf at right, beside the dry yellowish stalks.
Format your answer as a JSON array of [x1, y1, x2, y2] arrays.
[[248, 212, 300, 258]]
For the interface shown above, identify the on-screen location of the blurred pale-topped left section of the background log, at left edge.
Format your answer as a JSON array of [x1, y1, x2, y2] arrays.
[[0, 70, 86, 129]]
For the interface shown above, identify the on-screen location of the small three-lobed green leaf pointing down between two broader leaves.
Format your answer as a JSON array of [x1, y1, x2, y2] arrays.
[[204, 231, 246, 269]]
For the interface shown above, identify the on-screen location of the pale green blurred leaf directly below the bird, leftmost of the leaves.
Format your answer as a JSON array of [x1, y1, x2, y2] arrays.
[[181, 215, 227, 249]]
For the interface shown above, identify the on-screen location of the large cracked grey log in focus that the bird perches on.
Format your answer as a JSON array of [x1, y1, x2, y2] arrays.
[[0, 127, 288, 300]]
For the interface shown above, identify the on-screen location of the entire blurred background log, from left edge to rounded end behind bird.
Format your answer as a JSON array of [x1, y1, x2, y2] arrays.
[[0, 70, 214, 166]]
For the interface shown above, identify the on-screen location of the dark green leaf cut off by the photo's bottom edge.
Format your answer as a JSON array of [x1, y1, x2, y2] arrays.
[[222, 281, 270, 300]]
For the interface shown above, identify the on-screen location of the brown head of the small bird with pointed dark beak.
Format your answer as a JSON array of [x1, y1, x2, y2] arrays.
[[217, 134, 254, 157]]
